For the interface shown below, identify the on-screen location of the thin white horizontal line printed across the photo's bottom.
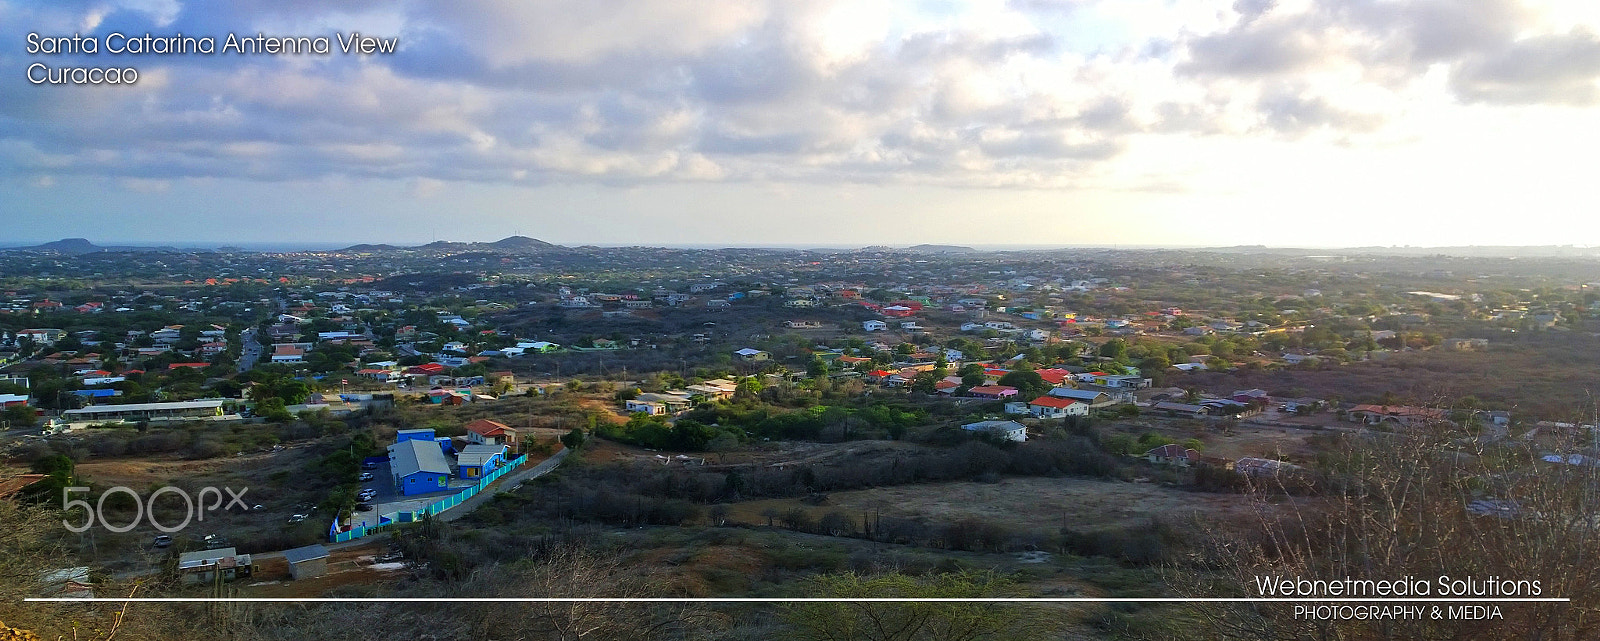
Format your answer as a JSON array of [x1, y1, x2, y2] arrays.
[[24, 596, 1571, 603]]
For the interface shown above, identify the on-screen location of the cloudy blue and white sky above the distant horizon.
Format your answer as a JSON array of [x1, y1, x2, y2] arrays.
[[0, 0, 1600, 246]]
